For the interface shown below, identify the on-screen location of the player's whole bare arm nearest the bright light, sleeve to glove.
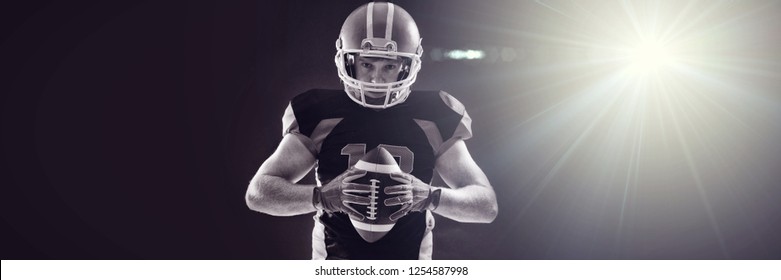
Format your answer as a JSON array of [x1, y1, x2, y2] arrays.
[[434, 140, 498, 223]]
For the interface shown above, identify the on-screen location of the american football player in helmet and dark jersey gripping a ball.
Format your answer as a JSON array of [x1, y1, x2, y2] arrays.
[[246, 2, 498, 259]]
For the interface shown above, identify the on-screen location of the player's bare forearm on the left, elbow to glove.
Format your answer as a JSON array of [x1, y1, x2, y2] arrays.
[[245, 175, 316, 216]]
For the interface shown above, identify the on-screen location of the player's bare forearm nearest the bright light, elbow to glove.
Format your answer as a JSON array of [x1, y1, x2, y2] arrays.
[[434, 185, 498, 223]]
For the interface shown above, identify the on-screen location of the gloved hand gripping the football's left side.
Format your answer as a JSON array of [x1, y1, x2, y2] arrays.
[[313, 168, 372, 221]]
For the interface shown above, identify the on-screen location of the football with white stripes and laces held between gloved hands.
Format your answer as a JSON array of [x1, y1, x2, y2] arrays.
[[351, 147, 401, 243]]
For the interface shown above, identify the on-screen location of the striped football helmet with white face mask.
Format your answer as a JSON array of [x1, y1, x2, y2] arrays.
[[334, 2, 423, 109]]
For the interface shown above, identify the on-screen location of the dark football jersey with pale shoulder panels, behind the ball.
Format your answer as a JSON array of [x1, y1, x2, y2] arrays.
[[283, 89, 472, 259]]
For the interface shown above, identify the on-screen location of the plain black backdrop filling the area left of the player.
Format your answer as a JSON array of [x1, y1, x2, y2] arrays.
[[2, 1, 496, 259]]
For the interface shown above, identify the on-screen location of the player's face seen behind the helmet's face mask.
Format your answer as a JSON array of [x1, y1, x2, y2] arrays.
[[355, 56, 402, 98]]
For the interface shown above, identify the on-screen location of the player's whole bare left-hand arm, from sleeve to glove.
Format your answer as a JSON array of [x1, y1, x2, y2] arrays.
[[245, 134, 316, 216]]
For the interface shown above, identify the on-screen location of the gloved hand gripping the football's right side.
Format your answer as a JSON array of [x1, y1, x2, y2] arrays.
[[384, 172, 441, 221]]
